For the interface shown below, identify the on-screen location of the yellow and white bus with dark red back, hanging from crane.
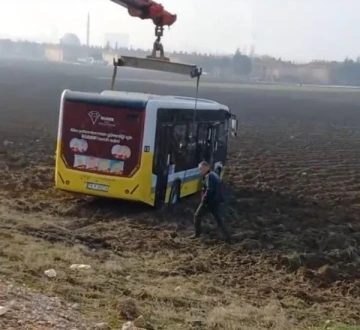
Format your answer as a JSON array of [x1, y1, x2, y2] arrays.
[[55, 90, 237, 208]]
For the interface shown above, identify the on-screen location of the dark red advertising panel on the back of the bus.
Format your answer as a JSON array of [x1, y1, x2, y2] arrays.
[[61, 101, 144, 177]]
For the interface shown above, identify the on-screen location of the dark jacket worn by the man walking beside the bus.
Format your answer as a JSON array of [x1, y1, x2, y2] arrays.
[[202, 171, 224, 205]]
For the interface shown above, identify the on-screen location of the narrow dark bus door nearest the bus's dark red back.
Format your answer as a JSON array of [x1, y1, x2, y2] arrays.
[[154, 124, 173, 207]]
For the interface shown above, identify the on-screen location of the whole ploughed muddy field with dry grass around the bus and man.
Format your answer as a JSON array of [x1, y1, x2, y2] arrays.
[[0, 58, 360, 330]]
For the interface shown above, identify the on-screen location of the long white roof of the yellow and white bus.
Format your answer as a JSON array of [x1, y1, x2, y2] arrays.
[[63, 90, 229, 111]]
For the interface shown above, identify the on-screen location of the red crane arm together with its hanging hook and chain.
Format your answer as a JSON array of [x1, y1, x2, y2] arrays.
[[111, 0, 177, 60]]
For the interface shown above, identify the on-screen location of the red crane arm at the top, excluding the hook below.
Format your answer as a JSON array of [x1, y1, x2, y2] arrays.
[[111, 0, 177, 26]]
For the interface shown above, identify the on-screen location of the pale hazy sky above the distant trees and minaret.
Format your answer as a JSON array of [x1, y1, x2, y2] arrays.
[[0, 0, 360, 62]]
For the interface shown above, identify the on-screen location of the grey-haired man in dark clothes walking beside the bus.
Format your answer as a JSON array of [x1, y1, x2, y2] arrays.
[[192, 161, 231, 243]]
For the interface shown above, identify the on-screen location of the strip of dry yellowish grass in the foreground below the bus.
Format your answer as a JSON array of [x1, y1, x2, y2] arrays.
[[0, 168, 358, 330]]
